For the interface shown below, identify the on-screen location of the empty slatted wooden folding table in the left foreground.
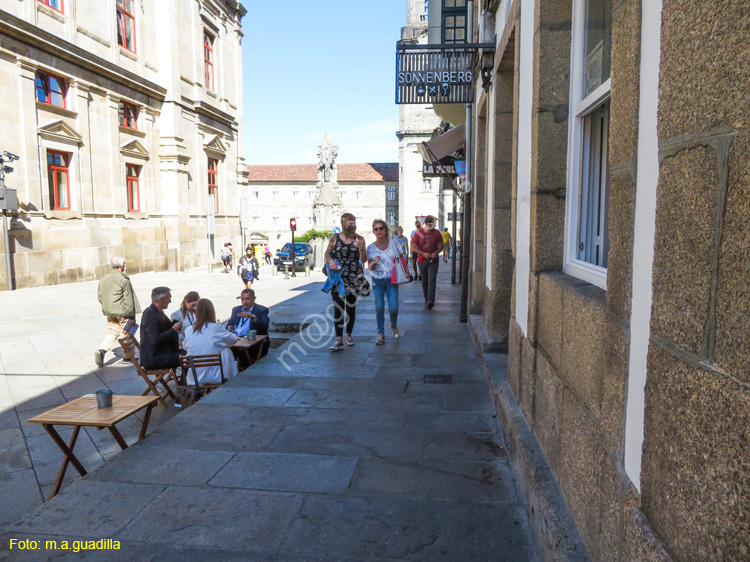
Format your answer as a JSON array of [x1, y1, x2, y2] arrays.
[[29, 394, 159, 499]]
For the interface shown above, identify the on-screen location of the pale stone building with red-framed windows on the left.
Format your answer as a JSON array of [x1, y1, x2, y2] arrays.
[[0, 0, 247, 289]]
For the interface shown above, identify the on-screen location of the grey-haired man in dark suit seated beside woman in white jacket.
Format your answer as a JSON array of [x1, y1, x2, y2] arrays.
[[141, 287, 185, 369]]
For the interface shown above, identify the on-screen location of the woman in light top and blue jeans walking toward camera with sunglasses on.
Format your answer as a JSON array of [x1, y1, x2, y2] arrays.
[[367, 219, 405, 345]]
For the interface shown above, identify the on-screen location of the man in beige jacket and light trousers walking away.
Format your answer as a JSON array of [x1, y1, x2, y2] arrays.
[[94, 256, 141, 368]]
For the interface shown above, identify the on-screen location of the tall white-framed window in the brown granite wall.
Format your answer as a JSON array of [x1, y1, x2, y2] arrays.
[[564, 0, 612, 288]]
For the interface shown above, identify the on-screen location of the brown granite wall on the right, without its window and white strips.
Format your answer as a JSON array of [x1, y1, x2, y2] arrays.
[[494, 0, 750, 562]]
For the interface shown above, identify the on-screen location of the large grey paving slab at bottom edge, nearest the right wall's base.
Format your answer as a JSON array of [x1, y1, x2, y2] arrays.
[[283, 496, 534, 562]]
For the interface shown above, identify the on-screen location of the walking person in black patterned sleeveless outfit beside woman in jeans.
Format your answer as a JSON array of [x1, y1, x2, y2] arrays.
[[325, 213, 370, 351]]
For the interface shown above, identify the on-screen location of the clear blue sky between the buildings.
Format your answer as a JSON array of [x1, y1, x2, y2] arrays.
[[242, 0, 406, 164]]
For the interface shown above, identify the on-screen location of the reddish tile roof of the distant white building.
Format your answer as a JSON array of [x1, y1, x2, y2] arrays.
[[247, 163, 398, 183]]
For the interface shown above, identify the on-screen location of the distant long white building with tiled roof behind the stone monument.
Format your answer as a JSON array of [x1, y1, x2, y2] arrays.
[[245, 163, 399, 252]]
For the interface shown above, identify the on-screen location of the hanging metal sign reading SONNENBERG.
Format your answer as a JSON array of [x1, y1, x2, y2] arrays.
[[396, 49, 475, 104]]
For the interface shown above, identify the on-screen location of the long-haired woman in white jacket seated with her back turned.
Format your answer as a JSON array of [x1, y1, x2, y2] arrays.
[[185, 299, 239, 385]]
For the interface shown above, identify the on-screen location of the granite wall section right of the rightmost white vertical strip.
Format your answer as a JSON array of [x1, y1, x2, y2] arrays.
[[641, 0, 750, 561]]
